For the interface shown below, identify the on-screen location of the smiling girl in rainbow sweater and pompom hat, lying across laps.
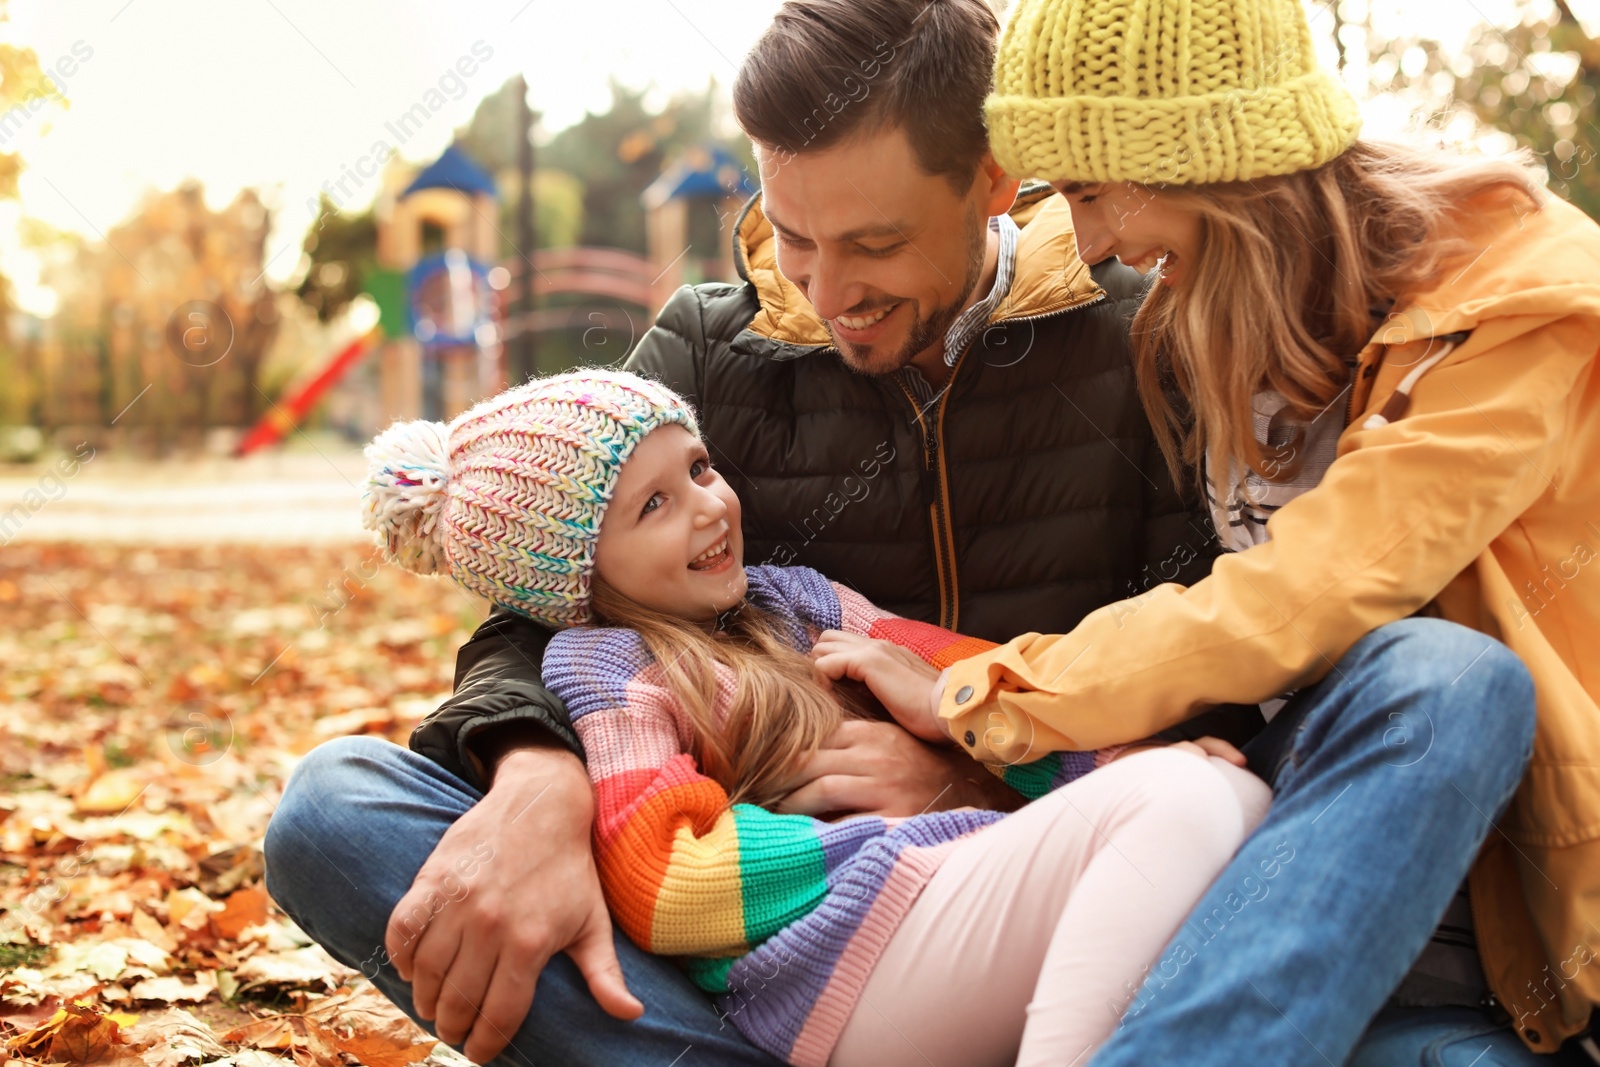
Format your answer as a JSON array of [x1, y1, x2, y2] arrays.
[[365, 371, 1267, 1067]]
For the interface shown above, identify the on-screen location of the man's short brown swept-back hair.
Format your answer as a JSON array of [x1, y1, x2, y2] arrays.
[[733, 0, 1000, 194]]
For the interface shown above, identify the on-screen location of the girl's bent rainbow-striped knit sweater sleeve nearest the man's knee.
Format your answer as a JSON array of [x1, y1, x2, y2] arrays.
[[547, 630, 844, 972]]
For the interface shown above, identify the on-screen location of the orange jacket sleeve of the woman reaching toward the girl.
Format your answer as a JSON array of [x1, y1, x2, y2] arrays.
[[939, 317, 1595, 761]]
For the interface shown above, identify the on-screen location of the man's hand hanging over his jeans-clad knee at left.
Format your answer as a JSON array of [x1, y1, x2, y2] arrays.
[[384, 744, 645, 1064]]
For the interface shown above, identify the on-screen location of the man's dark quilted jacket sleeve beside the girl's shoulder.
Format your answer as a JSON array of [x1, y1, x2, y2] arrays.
[[411, 606, 584, 789]]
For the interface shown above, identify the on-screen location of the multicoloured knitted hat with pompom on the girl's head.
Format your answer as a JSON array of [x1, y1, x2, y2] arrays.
[[362, 370, 699, 629]]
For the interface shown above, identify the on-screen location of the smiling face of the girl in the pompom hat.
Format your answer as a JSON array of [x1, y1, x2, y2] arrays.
[[595, 424, 747, 622]]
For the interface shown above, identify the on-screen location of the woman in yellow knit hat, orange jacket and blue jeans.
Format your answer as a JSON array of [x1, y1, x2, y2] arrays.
[[832, 0, 1600, 1067]]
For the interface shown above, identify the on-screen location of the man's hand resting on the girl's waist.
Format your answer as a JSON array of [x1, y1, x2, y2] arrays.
[[778, 723, 1022, 817]]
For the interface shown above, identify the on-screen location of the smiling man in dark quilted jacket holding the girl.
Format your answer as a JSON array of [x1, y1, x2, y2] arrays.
[[267, 0, 1222, 1065]]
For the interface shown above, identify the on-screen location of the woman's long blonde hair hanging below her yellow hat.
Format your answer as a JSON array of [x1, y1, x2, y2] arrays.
[[1133, 141, 1542, 490]]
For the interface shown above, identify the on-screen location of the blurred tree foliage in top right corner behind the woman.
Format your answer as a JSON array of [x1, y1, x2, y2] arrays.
[[1368, 0, 1600, 218]]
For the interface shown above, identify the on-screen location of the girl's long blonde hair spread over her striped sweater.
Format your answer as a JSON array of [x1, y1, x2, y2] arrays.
[[590, 574, 867, 808]]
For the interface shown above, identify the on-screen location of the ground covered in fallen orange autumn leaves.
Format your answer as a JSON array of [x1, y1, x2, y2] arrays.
[[0, 542, 483, 1067]]
